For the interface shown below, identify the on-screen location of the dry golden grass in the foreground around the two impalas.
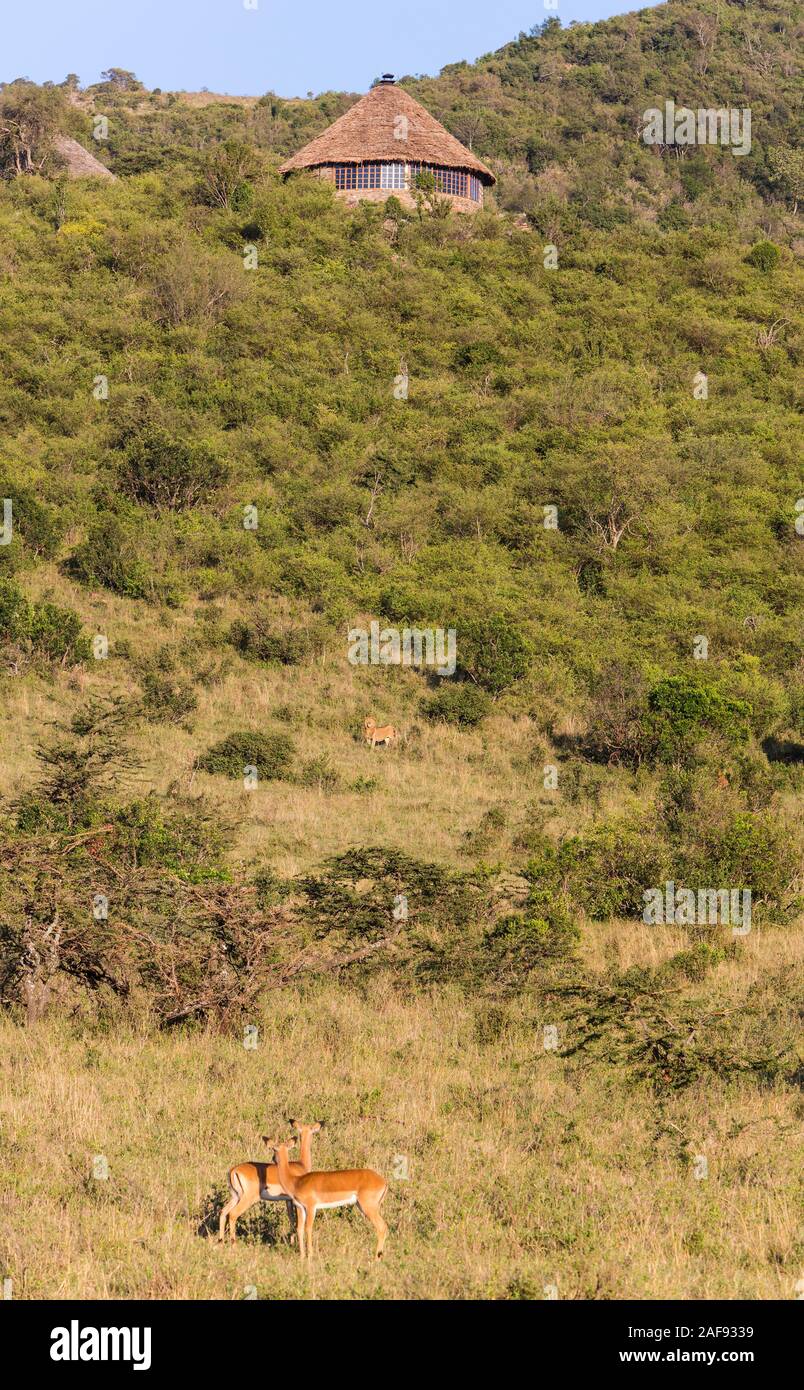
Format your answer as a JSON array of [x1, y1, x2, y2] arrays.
[[0, 924, 801, 1298]]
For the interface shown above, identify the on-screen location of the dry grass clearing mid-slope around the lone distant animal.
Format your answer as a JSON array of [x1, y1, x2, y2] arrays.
[[0, 566, 639, 874]]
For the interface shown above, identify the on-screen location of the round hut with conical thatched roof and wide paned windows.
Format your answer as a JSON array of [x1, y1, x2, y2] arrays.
[[280, 74, 497, 211]]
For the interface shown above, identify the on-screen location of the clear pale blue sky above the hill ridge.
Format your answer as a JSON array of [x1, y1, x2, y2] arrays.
[[0, 0, 658, 96]]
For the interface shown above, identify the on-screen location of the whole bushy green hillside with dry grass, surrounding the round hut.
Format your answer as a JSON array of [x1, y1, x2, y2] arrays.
[[0, 0, 804, 1297]]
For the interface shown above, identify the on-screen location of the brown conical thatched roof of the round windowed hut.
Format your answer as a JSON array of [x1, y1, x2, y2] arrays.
[[280, 82, 497, 183]]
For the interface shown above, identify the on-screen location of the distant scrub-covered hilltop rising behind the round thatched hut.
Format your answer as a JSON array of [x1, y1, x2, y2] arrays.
[[42, 0, 804, 236]]
